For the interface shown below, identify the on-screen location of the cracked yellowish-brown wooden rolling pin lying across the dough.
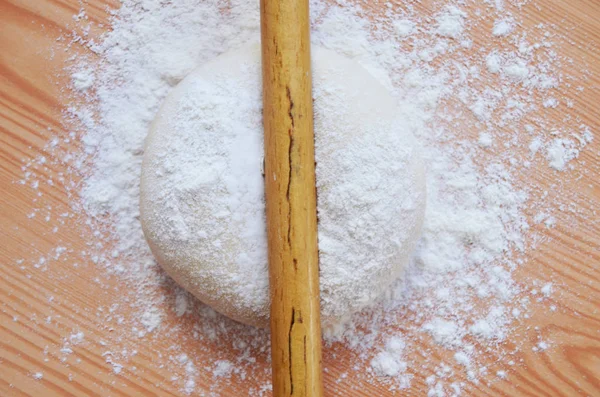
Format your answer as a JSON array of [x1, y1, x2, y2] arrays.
[[260, 0, 323, 397]]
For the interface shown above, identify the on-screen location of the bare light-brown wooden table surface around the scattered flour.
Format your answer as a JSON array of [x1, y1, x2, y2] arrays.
[[0, 0, 600, 397]]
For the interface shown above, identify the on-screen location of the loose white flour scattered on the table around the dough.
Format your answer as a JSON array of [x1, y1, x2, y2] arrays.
[[17, 0, 592, 396]]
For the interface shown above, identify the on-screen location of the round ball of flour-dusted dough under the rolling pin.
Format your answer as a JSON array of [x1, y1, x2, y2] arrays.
[[140, 46, 425, 328]]
